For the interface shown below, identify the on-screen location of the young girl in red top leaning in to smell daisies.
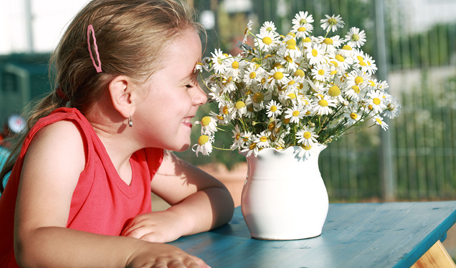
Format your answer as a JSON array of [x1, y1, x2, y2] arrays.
[[0, 0, 233, 267]]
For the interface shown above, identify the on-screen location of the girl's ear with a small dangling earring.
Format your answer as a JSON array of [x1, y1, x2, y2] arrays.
[[109, 75, 136, 118]]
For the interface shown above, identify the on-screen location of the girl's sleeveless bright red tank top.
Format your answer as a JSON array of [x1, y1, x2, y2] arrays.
[[0, 108, 163, 267]]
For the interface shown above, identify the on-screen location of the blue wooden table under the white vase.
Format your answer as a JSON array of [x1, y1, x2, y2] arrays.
[[170, 201, 456, 268]]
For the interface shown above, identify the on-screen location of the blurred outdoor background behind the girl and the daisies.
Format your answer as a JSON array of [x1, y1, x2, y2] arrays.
[[0, 0, 456, 262]]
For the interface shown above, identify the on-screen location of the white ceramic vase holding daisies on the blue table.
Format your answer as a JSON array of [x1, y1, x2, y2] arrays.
[[241, 145, 329, 240]]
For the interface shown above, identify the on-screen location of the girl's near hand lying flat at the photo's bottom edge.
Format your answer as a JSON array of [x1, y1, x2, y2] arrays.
[[126, 243, 210, 268]]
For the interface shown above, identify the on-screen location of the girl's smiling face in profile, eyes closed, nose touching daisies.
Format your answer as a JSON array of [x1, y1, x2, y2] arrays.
[[133, 29, 207, 151]]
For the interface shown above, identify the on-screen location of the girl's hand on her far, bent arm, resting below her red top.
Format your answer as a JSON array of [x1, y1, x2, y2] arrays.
[[121, 211, 184, 243]]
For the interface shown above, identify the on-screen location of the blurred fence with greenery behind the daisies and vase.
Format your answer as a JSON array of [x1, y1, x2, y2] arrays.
[[178, 0, 456, 201]]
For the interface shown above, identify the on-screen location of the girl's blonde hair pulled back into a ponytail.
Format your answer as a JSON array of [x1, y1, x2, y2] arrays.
[[0, 0, 202, 191]]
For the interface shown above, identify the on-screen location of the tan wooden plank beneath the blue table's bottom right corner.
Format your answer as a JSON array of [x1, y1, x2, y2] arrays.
[[411, 240, 456, 268]]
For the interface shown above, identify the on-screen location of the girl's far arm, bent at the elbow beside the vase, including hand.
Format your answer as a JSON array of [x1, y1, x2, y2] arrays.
[[122, 152, 234, 242]]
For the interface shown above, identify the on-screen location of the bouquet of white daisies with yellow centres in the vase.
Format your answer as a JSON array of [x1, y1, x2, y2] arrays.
[[193, 11, 400, 157]]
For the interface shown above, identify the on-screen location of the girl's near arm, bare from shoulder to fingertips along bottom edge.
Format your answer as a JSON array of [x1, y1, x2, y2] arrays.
[[14, 121, 207, 267]]
